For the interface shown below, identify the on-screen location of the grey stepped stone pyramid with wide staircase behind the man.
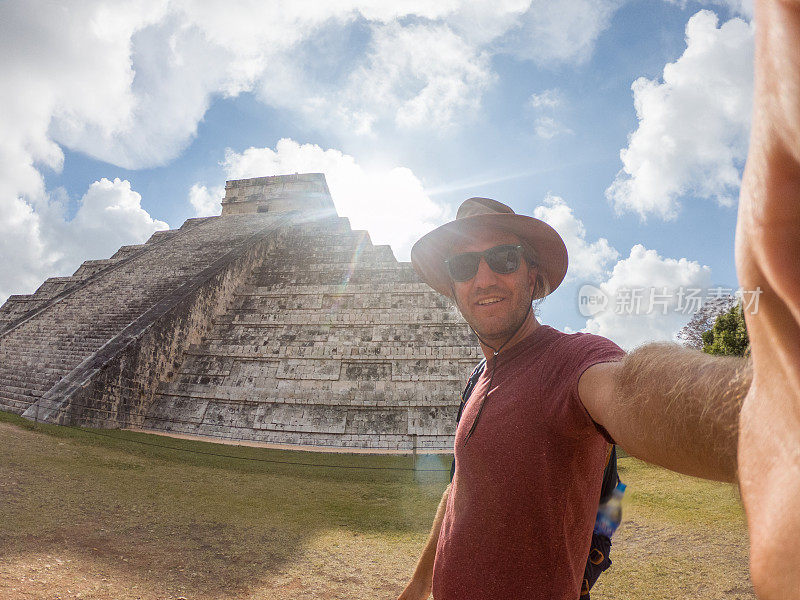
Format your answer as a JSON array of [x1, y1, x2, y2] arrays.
[[0, 173, 479, 449]]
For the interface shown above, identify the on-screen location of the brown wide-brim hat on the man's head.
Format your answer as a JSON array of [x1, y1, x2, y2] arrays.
[[411, 198, 569, 300]]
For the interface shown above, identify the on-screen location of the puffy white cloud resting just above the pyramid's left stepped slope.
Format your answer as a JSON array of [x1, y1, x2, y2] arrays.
[[0, 178, 167, 303]]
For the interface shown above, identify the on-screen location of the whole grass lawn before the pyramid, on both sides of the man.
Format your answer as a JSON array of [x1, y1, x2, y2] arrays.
[[0, 413, 753, 600]]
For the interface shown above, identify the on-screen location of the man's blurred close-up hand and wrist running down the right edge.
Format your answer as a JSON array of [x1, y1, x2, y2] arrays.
[[736, 0, 800, 600]]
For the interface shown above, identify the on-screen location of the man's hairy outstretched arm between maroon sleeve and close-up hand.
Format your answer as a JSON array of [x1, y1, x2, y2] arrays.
[[578, 343, 751, 481]]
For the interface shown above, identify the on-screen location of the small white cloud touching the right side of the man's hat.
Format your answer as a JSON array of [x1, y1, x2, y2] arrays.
[[533, 194, 619, 280]]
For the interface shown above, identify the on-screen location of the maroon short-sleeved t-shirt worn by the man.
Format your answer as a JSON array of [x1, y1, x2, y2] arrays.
[[433, 325, 625, 600]]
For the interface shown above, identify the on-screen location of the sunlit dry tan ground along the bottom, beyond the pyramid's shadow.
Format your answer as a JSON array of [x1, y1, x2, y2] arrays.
[[0, 523, 755, 600]]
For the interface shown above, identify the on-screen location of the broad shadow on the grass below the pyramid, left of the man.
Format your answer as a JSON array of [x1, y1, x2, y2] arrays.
[[0, 413, 450, 597]]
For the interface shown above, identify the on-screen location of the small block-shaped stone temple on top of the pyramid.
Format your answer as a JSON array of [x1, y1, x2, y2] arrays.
[[222, 173, 336, 217]]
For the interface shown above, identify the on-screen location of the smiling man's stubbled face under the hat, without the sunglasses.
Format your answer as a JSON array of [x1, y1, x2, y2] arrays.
[[452, 230, 537, 342]]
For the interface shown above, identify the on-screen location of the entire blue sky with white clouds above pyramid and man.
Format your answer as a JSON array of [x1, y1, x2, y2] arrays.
[[0, 0, 752, 347]]
